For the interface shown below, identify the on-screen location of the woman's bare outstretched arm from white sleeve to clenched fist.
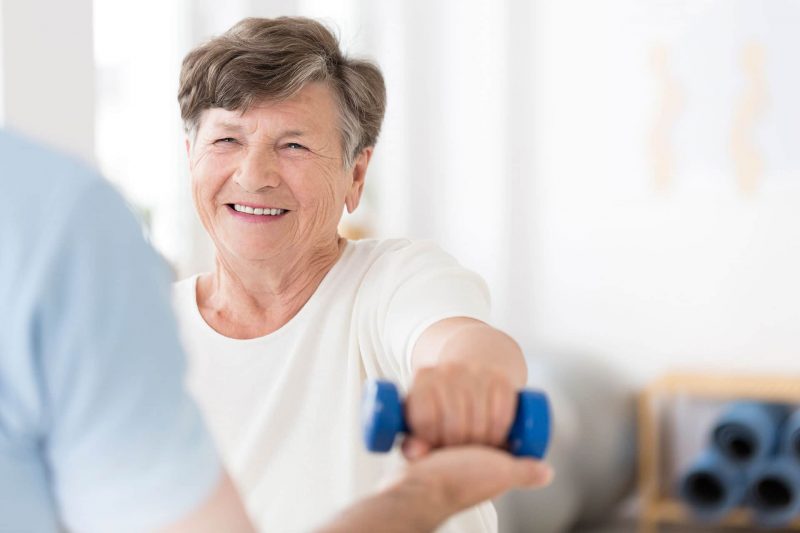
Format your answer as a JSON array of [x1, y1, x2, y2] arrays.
[[403, 317, 528, 459]]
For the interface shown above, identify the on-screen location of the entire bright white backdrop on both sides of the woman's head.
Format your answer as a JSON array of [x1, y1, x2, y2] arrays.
[[6, 0, 800, 528]]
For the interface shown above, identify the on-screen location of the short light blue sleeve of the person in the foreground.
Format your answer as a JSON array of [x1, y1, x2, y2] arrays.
[[36, 183, 221, 532]]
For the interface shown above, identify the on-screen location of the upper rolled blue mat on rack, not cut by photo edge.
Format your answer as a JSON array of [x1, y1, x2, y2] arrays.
[[711, 402, 788, 466]]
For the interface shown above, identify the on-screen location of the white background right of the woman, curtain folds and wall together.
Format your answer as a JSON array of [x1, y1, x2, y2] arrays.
[[324, 0, 800, 379]]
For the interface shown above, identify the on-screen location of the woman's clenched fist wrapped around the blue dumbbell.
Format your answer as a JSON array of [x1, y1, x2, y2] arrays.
[[403, 361, 517, 461]]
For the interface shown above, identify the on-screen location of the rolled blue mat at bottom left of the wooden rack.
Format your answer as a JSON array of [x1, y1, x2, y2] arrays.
[[678, 449, 747, 522]]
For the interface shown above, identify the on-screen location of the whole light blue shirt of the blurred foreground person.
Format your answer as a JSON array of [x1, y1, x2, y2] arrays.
[[0, 131, 221, 533]]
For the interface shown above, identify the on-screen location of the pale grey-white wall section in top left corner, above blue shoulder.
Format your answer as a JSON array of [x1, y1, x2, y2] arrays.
[[0, 0, 94, 160]]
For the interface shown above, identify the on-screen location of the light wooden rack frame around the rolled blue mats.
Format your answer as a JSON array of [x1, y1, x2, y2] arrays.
[[639, 374, 800, 533]]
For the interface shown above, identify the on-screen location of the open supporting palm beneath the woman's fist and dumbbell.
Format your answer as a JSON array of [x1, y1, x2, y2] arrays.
[[404, 446, 553, 516]]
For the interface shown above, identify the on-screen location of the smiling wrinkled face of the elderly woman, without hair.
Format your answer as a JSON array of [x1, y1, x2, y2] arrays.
[[187, 83, 371, 260]]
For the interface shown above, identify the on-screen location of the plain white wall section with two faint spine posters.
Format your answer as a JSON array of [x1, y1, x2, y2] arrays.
[[528, 0, 800, 382]]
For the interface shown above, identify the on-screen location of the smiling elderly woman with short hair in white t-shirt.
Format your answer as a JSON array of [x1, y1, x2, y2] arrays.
[[174, 18, 527, 531]]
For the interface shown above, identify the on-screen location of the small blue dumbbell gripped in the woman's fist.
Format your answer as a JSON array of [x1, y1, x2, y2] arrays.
[[362, 380, 550, 459]]
